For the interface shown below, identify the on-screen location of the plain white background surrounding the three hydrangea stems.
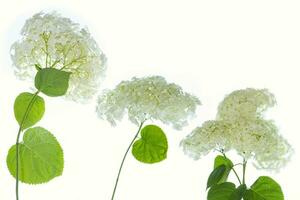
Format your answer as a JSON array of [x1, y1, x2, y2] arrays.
[[0, 0, 300, 200]]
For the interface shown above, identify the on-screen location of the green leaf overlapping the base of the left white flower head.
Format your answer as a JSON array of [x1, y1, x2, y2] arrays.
[[35, 68, 70, 97]]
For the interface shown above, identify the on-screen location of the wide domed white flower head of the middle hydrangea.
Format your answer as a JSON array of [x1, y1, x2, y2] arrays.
[[96, 76, 201, 129]]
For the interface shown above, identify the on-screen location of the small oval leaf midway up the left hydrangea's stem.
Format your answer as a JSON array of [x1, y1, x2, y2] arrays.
[[14, 92, 45, 129]]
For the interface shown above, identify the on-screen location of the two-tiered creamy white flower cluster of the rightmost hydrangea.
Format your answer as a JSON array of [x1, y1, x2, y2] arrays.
[[181, 88, 292, 170]]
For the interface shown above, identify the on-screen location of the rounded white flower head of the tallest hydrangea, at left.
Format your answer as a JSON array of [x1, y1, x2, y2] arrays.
[[11, 12, 106, 102]]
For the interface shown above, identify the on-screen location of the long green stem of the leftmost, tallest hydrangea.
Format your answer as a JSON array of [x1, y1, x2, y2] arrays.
[[16, 91, 39, 200]]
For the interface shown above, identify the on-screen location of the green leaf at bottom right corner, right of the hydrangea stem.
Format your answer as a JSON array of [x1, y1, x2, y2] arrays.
[[244, 176, 284, 200]]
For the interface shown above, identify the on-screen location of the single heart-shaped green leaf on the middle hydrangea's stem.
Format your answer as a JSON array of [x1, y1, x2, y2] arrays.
[[132, 125, 168, 163]]
